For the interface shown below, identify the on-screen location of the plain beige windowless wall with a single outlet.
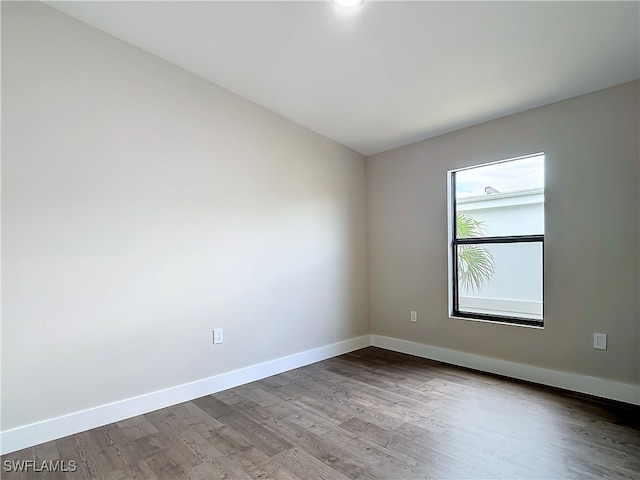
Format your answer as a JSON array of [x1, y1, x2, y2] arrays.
[[2, 2, 369, 429]]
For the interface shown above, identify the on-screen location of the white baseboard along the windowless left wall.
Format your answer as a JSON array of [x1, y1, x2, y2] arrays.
[[0, 335, 371, 455]]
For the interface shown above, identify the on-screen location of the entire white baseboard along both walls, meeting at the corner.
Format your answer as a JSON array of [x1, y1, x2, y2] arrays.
[[0, 335, 640, 455]]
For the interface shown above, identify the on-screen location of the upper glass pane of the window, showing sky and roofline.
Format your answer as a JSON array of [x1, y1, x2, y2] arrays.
[[455, 155, 544, 238]]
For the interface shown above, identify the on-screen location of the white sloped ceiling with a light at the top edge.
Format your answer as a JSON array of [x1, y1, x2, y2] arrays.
[[47, 1, 640, 155]]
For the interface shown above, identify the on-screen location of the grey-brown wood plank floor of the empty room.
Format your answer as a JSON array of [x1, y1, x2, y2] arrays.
[[2, 347, 640, 480]]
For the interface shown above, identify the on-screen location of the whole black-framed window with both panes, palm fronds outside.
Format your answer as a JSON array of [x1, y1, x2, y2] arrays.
[[448, 153, 544, 326]]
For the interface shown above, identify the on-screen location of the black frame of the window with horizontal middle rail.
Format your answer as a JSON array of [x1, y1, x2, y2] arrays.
[[448, 156, 546, 327]]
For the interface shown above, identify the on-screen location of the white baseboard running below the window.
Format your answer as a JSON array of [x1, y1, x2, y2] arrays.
[[371, 335, 640, 405]]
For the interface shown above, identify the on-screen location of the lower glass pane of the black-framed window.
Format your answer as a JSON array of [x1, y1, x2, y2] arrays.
[[457, 242, 543, 320]]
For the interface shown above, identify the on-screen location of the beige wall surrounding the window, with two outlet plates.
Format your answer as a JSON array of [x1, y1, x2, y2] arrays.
[[367, 82, 640, 384]]
